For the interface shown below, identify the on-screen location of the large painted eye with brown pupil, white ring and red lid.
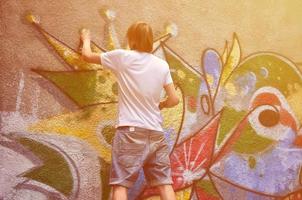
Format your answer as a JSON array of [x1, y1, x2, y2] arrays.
[[248, 87, 297, 141]]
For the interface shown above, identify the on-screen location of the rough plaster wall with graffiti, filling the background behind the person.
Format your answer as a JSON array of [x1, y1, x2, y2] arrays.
[[0, 0, 302, 200]]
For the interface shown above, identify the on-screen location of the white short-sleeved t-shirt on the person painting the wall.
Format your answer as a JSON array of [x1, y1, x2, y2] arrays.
[[100, 49, 173, 131]]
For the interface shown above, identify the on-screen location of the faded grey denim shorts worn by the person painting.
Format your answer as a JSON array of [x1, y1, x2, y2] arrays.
[[109, 126, 173, 188]]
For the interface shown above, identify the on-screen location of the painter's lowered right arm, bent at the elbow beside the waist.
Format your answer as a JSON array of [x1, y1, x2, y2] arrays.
[[159, 83, 179, 110]]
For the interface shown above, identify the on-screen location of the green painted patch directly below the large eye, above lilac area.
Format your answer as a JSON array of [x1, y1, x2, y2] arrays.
[[233, 124, 274, 154]]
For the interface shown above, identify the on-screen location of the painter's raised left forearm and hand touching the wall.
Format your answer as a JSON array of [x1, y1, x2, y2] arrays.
[[81, 29, 101, 64]]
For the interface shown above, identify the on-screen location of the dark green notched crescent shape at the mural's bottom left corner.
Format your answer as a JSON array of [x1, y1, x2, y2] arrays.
[[18, 138, 73, 196]]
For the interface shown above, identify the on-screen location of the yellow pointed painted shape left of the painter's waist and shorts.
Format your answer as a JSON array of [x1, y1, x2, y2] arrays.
[[28, 104, 117, 163]]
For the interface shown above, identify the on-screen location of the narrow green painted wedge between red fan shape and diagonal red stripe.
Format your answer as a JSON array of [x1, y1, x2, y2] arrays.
[[217, 107, 246, 145]]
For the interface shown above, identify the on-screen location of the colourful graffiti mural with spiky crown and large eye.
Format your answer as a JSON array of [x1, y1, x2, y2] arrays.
[[0, 9, 302, 200]]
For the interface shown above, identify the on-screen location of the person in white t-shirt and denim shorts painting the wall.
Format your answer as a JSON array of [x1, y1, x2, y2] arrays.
[[81, 22, 179, 200]]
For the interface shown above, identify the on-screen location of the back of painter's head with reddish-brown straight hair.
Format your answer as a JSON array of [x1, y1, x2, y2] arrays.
[[127, 22, 153, 53]]
